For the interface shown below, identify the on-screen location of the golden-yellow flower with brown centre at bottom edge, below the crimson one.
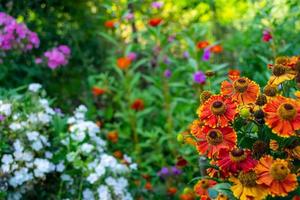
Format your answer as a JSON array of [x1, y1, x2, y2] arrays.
[[229, 171, 269, 200]]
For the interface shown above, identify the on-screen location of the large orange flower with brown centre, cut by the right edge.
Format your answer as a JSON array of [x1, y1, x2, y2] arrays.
[[263, 96, 300, 137]]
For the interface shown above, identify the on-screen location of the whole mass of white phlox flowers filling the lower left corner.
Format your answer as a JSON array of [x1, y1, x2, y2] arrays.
[[0, 84, 137, 200]]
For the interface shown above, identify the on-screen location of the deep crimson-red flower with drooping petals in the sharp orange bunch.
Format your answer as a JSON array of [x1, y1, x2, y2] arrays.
[[217, 149, 257, 173]]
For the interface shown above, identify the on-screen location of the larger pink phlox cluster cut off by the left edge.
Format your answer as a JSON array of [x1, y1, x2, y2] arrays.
[[0, 12, 40, 51]]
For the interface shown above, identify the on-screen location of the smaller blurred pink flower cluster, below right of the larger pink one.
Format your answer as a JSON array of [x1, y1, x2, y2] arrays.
[[42, 45, 71, 69]]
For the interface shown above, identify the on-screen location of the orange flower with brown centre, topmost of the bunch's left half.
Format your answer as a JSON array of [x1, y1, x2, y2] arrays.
[[221, 76, 259, 104]]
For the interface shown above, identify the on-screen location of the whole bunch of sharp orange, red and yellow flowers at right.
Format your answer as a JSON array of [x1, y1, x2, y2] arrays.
[[185, 56, 300, 200]]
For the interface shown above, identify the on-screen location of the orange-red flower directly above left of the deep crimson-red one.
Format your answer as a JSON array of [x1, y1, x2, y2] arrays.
[[197, 126, 236, 158]]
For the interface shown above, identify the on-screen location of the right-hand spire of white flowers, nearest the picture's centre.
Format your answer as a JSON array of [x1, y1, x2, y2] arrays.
[[61, 106, 136, 200]]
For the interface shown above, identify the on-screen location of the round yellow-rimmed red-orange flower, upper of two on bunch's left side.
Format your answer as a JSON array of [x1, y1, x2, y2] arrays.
[[197, 95, 237, 127]]
